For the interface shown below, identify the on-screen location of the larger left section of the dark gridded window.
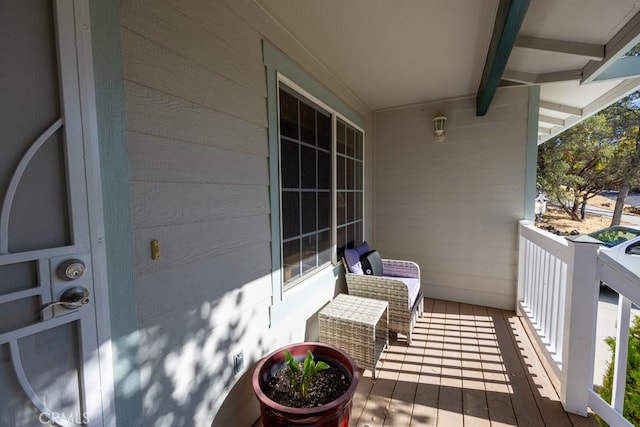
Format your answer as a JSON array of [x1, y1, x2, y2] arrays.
[[279, 87, 332, 289]]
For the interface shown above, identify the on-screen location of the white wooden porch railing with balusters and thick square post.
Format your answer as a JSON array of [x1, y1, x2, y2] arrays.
[[517, 221, 640, 426]]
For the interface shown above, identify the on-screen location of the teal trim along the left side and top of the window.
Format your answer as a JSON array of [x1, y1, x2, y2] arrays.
[[262, 40, 367, 324]]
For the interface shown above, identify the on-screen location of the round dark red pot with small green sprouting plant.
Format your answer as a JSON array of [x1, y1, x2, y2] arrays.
[[253, 342, 360, 427]]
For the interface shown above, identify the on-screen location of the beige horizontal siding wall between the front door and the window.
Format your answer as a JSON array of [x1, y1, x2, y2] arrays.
[[120, 0, 371, 426]]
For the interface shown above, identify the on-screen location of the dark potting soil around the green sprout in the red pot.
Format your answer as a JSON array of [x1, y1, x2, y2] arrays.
[[265, 367, 351, 408]]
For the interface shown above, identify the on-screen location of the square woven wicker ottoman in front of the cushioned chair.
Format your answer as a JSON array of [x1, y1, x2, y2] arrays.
[[318, 294, 389, 378]]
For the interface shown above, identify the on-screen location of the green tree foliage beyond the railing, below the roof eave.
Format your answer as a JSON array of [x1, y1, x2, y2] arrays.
[[538, 88, 640, 225]]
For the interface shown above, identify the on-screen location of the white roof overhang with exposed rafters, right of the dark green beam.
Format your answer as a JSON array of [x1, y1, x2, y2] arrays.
[[502, 1, 640, 144]]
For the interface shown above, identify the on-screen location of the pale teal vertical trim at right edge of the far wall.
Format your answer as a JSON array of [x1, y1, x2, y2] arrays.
[[524, 85, 540, 221]]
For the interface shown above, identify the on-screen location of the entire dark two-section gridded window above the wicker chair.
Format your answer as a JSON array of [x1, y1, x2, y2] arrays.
[[278, 82, 364, 290]]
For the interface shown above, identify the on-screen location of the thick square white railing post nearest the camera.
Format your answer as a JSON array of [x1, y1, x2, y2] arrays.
[[560, 236, 600, 416]]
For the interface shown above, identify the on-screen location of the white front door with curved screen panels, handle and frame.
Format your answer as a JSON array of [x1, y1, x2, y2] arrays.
[[0, 0, 113, 427]]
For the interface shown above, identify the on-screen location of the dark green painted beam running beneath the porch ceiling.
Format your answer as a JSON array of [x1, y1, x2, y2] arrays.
[[476, 0, 530, 116]]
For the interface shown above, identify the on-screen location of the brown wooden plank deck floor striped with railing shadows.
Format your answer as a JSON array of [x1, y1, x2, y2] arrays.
[[350, 299, 598, 427]]
